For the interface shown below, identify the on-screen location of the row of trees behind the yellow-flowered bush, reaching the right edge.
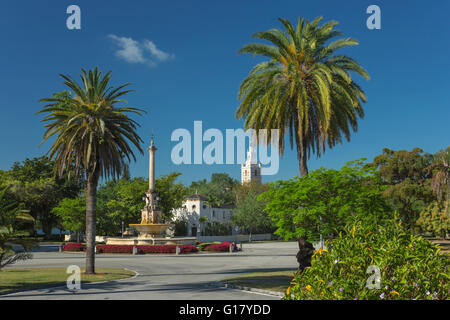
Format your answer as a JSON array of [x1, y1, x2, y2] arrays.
[[264, 147, 450, 241]]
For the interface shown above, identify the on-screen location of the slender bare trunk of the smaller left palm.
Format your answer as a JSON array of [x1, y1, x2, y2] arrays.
[[86, 173, 98, 274]]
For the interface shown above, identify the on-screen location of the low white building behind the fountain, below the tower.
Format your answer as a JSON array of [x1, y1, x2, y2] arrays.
[[174, 194, 234, 237]]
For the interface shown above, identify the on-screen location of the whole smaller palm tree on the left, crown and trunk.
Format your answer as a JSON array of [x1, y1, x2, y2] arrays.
[[38, 68, 145, 273]]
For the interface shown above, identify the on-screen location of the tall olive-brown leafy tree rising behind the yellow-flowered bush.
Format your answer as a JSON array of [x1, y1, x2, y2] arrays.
[[372, 148, 434, 229]]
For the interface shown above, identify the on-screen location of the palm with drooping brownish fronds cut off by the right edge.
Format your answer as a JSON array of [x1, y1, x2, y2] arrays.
[[428, 146, 450, 214]]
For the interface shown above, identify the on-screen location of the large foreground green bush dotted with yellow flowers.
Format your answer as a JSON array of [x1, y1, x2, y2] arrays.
[[284, 218, 450, 300]]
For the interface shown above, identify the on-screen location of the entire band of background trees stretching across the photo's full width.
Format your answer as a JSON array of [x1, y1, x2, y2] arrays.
[[0, 148, 450, 240]]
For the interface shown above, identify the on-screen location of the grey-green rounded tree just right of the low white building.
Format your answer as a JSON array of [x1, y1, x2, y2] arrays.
[[231, 191, 272, 241]]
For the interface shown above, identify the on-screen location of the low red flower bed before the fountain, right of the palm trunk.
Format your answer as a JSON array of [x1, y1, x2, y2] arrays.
[[97, 244, 198, 254]]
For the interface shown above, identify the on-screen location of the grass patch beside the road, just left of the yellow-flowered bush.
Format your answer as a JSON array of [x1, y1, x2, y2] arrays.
[[222, 270, 297, 292]]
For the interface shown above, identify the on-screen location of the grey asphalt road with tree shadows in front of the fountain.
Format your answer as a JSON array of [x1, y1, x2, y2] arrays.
[[0, 242, 298, 300]]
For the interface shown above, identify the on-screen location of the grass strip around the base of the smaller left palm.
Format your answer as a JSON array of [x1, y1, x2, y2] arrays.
[[0, 268, 134, 294]]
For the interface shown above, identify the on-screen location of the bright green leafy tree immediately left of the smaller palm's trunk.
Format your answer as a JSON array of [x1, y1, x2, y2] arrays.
[[52, 196, 86, 242]]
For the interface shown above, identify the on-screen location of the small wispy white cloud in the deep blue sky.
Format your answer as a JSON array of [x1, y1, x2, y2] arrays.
[[108, 34, 175, 67]]
